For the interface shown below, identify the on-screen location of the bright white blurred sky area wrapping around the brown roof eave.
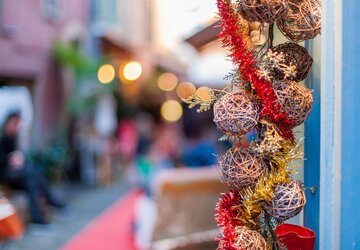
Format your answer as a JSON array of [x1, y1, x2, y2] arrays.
[[157, 0, 233, 86]]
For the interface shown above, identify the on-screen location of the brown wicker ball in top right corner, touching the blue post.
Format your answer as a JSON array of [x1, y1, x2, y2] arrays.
[[277, 0, 321, 42]]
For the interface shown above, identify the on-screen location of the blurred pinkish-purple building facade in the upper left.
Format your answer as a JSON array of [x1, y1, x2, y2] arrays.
[[0, 0, 89, 145]]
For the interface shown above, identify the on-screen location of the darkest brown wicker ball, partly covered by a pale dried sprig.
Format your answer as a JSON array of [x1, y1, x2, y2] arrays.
[[272, 42, 313, 82]]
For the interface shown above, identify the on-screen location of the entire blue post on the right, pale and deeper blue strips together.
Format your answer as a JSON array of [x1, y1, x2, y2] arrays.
[[320, 0, 360, 250]]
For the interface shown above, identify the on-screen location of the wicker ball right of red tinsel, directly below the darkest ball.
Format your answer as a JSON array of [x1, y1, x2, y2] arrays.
[[273, 81, 313, 126]]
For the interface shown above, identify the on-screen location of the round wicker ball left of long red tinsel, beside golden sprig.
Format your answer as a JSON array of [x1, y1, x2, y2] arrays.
[[214, 91, 259, 135]]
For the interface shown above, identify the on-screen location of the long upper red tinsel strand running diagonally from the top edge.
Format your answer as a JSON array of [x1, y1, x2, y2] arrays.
[[217, 0, 295, 141]]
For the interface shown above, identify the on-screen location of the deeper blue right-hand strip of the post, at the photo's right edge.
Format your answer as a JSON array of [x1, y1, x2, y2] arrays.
[[340, 0, 360, 249]]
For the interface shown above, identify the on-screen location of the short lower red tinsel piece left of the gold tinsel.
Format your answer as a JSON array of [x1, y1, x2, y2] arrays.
[[215, 191, 240, 250]]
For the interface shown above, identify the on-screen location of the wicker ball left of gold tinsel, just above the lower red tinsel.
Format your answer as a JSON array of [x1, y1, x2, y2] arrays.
[[219, 148, 265, 189]]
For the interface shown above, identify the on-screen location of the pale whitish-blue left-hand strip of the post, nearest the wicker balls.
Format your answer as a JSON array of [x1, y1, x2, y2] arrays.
[[318, 0, 342, 250]]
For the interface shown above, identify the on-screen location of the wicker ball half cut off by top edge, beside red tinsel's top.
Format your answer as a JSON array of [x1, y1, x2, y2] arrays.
[[238, 0, 288, 23]]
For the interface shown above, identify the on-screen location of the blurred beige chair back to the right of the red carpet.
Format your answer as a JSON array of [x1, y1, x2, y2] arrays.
[[151, 168, 227, 250]]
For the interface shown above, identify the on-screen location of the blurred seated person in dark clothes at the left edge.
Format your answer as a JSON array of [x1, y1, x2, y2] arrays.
[[0, 112, 65, 224]]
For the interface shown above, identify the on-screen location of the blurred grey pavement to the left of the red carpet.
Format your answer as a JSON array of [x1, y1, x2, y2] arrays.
[[0, 179, 131, 250]]
